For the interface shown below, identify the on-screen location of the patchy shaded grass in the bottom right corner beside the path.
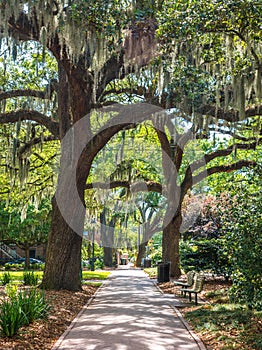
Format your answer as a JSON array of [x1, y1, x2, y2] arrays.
[[185, 304, 262, 350]]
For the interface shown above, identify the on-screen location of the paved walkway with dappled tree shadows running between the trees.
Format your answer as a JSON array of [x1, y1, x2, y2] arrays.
[[53, 269, 206, 350]]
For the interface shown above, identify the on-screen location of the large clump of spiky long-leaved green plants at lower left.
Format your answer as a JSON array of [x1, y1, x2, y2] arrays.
[[0, 289, 50, 337]]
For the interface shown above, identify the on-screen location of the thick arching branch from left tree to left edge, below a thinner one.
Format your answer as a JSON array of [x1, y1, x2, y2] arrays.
[[0, 110, 59, 137]]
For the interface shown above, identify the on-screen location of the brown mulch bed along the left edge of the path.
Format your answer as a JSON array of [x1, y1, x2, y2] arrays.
[[0, 285, 98, 350]]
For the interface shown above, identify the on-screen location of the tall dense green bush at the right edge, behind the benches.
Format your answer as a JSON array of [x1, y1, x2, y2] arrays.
[[219, 182, 262, 311]]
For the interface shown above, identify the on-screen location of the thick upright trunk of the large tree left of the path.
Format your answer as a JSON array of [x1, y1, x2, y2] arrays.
[[42, 62, 91, 291]]
